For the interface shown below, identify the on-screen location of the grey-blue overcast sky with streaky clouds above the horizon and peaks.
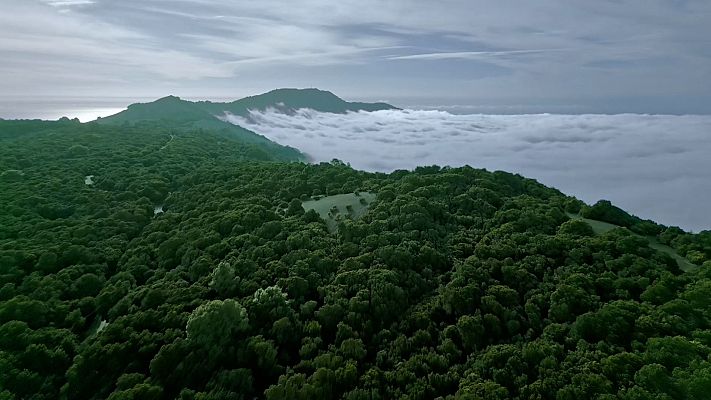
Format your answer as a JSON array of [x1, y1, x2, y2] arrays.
[[0, 0, 711, 113]]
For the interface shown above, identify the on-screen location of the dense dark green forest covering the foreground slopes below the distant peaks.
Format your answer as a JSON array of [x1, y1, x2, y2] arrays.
[[0, 119, 711, 400]]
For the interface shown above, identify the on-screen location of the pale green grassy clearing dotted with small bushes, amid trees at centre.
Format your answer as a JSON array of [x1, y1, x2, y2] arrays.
[[301, 192, 375, 232]]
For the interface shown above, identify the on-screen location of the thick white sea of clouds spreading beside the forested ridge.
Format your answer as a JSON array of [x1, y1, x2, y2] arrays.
[[227, 109, 711, 232]]
